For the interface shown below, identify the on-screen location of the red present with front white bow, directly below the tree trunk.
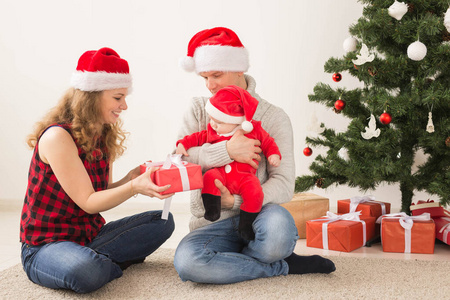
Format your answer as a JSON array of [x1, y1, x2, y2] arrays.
[[377, 212, 436, 254]]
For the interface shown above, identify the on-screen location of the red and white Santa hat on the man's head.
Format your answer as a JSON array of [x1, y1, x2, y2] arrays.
[[180, 27, 249, 73]]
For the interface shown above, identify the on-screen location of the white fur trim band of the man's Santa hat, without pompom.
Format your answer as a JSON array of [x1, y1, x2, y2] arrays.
[[194, 45, 250, 73]]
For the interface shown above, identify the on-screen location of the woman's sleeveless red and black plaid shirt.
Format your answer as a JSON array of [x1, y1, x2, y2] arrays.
[[20, 124, 109, 245]]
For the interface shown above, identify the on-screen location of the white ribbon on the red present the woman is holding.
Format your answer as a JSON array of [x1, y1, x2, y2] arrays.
[[145, 154, 190, 220]]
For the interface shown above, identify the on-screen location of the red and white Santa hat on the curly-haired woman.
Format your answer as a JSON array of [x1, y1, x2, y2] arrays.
[[70, 48, 132, 92]]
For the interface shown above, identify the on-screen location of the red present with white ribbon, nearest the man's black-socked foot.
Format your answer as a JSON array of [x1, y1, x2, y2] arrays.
[[306, 212, 375, 252]]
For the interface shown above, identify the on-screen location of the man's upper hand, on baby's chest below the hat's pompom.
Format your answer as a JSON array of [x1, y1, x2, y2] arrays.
[[227, 129, 262, 169]]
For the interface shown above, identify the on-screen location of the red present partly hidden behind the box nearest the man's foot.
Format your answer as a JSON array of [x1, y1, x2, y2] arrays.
[[337, 196, 391, 218]]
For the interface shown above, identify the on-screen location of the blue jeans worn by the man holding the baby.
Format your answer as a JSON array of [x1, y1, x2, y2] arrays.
[[174, 204, 298, 284]]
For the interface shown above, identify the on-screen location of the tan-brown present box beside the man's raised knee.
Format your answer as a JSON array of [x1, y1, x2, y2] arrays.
[[281, 193, 330, 239]]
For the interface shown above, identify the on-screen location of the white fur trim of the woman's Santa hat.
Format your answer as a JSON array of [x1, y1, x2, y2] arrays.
[[70, 71, 132, 92]]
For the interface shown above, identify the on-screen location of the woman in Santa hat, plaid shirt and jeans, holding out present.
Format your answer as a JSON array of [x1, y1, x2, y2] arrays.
[[20, 48, 174, 293]]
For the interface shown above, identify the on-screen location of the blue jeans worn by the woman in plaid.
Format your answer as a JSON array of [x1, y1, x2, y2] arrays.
[[22, 211, 175, 293]]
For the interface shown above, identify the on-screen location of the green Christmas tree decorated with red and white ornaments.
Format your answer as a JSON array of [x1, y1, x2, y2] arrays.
[[295, 0, 450, 212]]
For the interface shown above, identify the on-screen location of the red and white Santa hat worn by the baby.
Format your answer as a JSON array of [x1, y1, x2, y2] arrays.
[[205, 85, 258, 132]]
